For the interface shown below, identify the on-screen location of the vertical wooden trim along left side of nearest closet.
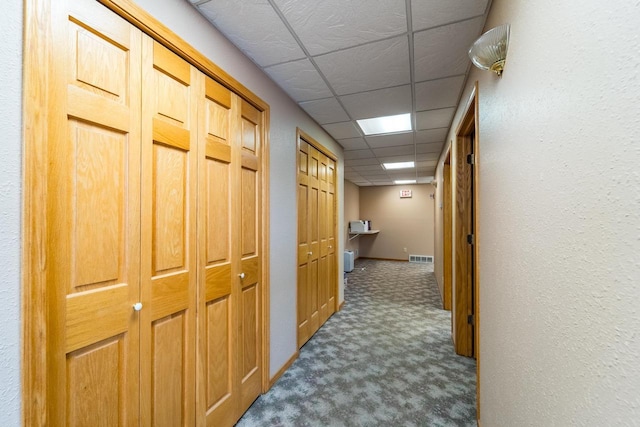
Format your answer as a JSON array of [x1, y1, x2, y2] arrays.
[[21, 0, 51, 426]]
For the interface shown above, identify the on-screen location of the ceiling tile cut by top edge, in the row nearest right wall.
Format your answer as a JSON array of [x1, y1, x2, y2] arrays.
[[411, 0, 488, 31]]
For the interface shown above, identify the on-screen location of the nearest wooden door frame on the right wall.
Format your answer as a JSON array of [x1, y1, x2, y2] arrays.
[[456, 81, 480, 420]]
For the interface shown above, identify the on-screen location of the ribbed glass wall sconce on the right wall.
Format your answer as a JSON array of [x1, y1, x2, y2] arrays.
[[469, 24, 509, 76]]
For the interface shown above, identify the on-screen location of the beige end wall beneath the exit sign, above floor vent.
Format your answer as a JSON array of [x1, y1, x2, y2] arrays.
[[358, 184, 435, 260]]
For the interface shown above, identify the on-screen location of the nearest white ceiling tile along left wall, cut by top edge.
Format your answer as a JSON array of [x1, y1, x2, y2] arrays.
[[197, 0, 306, 67]]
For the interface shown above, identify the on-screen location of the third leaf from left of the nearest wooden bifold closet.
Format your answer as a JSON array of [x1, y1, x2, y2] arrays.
[[197, 77, 239, 426]]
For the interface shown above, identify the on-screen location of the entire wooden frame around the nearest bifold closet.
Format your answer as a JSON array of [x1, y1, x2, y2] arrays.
[[21, 0, 270, 425]]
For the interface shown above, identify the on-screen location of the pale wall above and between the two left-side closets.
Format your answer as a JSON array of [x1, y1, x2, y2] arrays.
[[131, 0, 344, 375]]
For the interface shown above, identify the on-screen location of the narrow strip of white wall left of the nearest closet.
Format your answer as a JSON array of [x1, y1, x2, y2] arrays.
[[0, 0, 22, 426]]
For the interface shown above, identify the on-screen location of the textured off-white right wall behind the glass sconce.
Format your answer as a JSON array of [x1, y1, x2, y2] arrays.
[[439, 0, 640, 427]]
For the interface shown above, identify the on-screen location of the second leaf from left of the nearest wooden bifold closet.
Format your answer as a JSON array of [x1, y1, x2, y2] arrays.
[[140, 36, 202, 426]]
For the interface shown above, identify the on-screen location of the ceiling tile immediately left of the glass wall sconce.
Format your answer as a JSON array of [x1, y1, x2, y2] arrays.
[[413, 17, 484, 81]]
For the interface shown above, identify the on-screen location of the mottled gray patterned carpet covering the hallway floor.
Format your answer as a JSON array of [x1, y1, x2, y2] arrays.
[[237, 260, 476, 427]]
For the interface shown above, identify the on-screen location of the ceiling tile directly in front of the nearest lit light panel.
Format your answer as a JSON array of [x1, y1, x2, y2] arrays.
[[340, 85, 410, 119]]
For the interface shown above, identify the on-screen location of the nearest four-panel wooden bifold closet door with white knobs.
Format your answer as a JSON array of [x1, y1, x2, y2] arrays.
[[24, 0, 265, 427]]
